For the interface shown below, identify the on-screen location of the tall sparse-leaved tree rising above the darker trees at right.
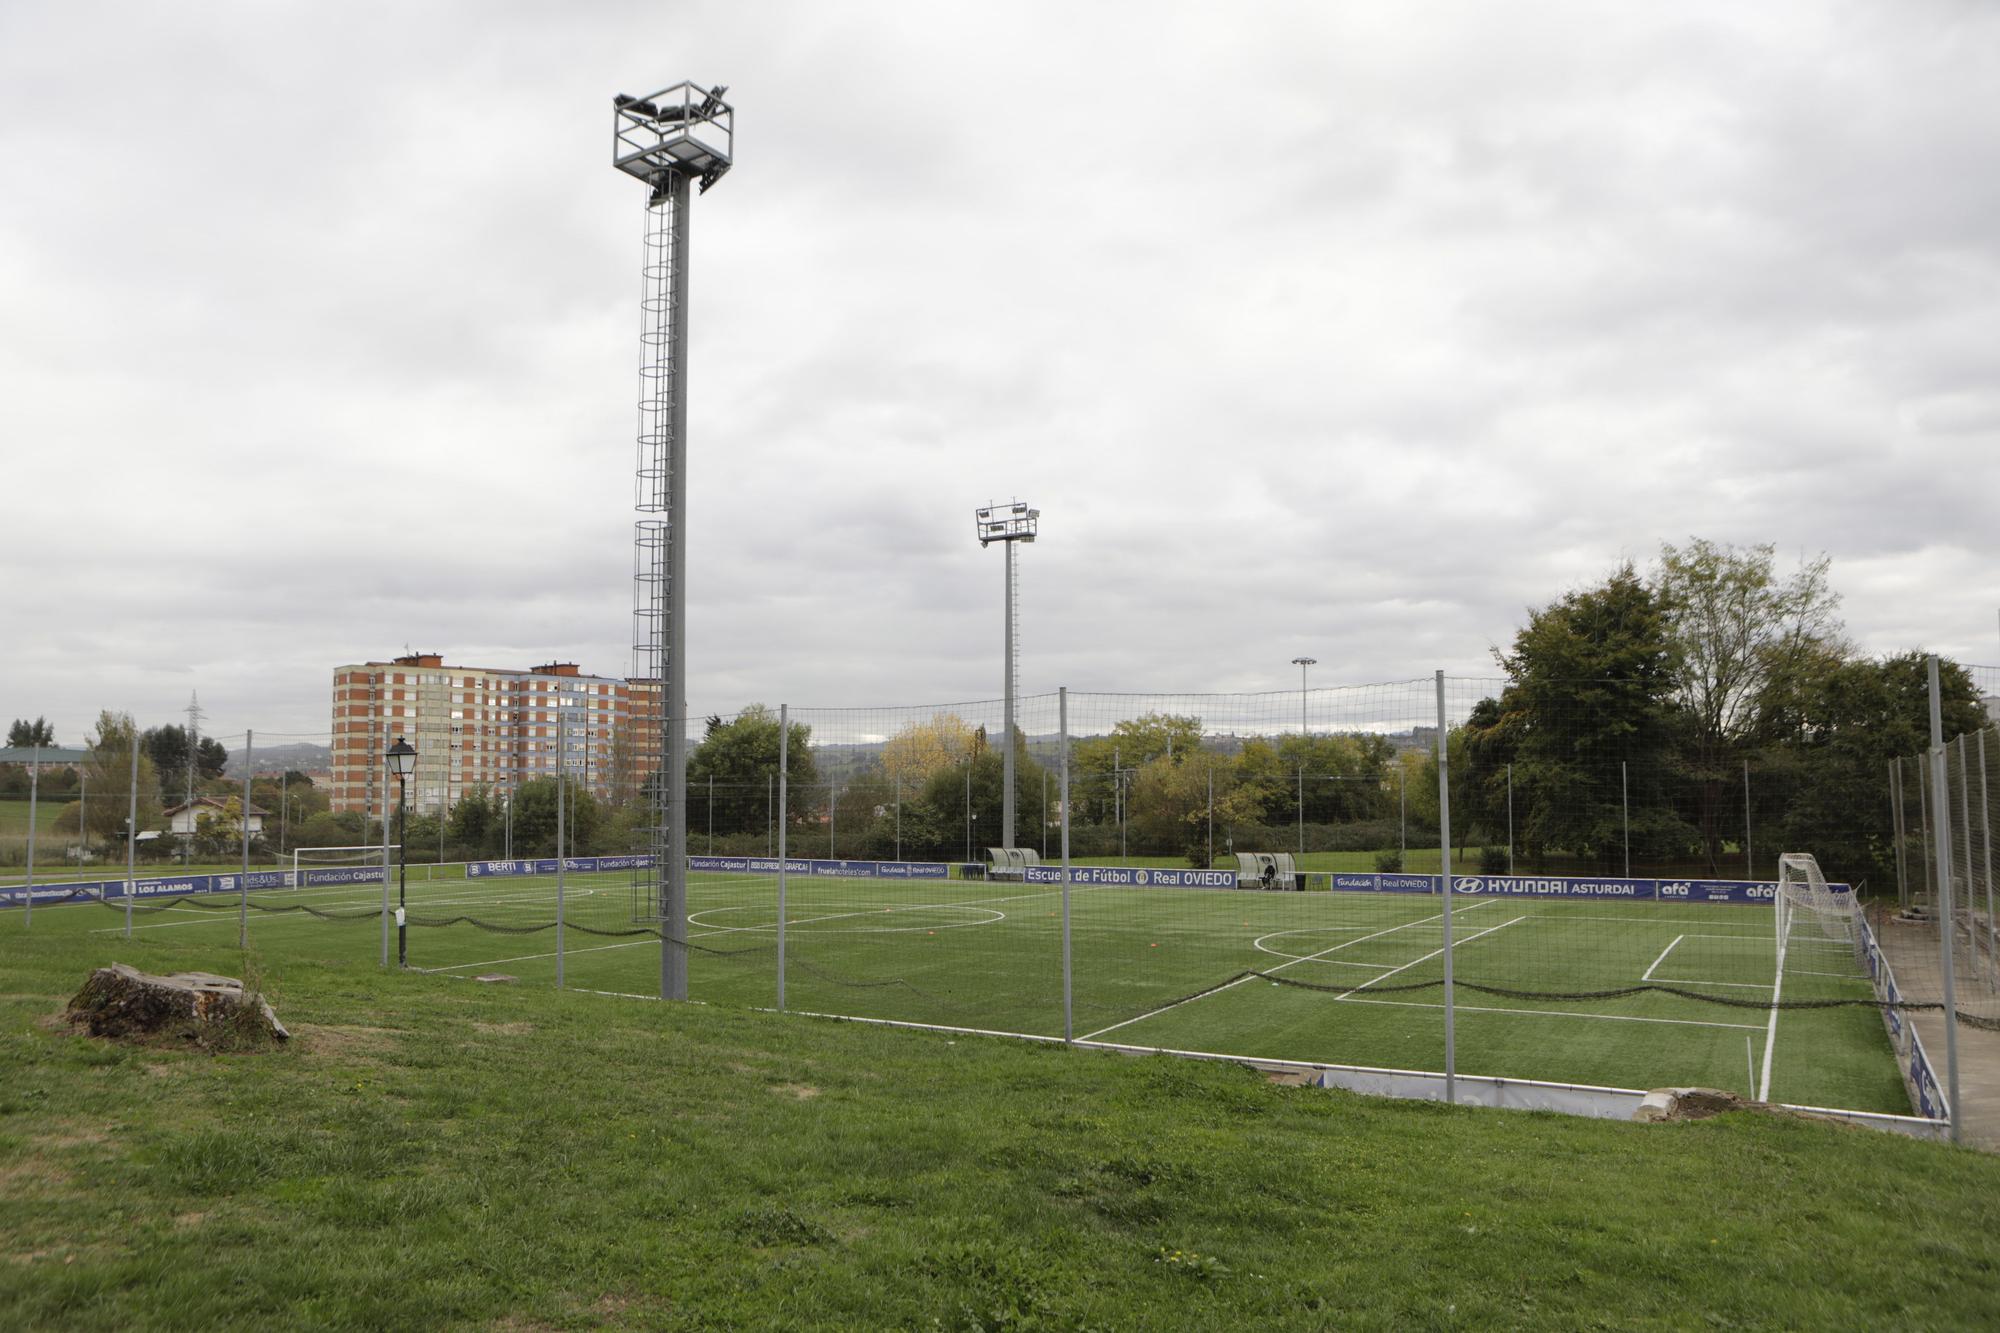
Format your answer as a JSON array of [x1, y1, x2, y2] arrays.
[[1656, 538, 1844, 873]]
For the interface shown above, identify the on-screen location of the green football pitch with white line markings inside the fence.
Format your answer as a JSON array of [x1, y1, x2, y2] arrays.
[[19, 860, 1910, 1115]]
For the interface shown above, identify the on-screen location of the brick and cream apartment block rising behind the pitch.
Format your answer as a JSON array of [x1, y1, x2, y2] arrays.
[[332, 652, 658, 813]]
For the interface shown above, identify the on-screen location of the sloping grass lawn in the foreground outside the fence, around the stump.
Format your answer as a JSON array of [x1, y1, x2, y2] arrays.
[[0, 907, 2000, 1329]]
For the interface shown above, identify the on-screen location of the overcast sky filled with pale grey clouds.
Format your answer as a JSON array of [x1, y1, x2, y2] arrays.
[[0, 0, 2000, 745]]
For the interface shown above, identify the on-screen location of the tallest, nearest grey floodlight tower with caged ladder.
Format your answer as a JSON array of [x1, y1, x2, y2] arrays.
[[612, 82, 736, 999]]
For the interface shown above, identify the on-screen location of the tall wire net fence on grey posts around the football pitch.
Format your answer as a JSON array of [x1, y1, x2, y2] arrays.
[[0, 669, 2000, 1117]]
